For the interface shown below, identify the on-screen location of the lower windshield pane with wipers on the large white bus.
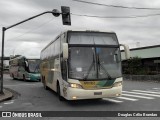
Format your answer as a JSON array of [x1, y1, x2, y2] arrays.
[[68, 47, 122, 80]]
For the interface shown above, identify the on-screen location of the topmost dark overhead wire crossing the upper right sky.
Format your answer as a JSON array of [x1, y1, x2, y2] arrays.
[[72, 0, 160, 10]]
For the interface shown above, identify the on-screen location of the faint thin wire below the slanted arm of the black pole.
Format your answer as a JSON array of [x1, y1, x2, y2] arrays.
[[6, 18, 53, 41]]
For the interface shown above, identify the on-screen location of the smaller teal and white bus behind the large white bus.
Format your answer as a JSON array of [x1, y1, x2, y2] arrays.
[[9, 56, 40, 81]]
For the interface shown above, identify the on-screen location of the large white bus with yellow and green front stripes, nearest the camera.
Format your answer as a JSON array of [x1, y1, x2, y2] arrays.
[[40, 30, 129, 100]]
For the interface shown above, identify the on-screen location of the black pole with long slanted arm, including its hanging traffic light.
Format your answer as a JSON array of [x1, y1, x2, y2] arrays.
[[0, 6, 71, 94]]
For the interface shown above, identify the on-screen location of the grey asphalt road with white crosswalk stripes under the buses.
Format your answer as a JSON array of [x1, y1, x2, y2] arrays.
[[0, 76, 160, 120]]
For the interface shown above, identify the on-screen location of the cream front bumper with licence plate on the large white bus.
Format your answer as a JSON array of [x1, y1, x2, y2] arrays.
[[65, 86, 122, 100]]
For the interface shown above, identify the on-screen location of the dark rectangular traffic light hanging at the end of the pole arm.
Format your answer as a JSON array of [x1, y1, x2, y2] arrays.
[[61, 6, 71, 25]]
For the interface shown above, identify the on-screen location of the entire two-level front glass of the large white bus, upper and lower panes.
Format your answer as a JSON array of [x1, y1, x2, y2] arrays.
[[68, 33, 122, 80]]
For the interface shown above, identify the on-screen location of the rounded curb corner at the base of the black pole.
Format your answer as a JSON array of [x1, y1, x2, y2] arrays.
[[0, 89, 13, 102]]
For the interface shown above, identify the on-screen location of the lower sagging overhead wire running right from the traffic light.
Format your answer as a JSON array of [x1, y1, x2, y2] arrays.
[[71, 13, 160, 18]]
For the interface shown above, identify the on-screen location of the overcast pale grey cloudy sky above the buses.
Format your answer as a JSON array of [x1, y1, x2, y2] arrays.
[[0, 0, 160, 58]]
